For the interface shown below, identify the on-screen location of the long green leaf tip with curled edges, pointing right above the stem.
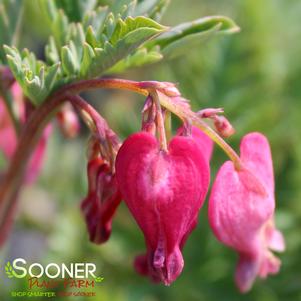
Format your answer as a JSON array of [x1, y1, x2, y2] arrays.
[[146, 16, 239, 57]]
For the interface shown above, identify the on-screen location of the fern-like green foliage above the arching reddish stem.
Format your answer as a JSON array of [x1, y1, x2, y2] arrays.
[[0, 0, 237, 105]]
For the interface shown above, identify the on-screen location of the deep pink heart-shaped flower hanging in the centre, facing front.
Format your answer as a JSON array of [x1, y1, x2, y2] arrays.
[[116, 132, 210, 285]]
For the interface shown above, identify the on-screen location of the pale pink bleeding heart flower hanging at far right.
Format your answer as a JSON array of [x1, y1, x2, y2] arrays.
[[209, 133, 285, 292]]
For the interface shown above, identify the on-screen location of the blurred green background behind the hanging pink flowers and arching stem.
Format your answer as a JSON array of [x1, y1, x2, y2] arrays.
[[0, 0, 301, 301]]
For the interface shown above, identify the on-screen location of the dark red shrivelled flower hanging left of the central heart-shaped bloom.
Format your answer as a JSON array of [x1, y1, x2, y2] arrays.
[[81, 157, 121, 244]]
